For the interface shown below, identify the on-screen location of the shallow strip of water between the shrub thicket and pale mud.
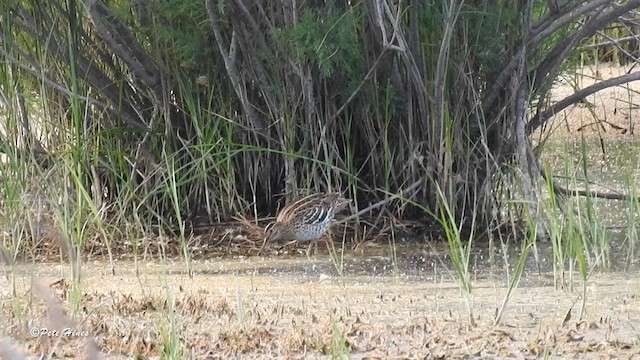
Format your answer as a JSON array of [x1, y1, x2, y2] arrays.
[[5, 239, 640, 287]]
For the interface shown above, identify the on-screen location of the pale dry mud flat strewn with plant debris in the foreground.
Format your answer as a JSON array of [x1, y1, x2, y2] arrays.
[[0, 255, 640, 359]]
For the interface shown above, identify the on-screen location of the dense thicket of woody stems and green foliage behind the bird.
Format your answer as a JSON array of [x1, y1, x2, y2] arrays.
[[0, 0, 640, 258]]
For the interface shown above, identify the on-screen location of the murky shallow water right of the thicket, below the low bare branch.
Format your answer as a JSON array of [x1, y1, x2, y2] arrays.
[[541, 137, 640, 271]]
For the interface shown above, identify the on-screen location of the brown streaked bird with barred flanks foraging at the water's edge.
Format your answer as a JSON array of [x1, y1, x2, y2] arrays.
[[265, 193, 351, 256]]
